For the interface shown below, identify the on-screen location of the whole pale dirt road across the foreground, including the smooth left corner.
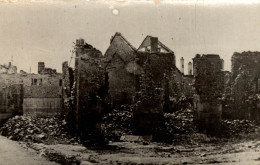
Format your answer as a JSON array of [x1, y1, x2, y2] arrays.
[[0, 132, 260, 165]]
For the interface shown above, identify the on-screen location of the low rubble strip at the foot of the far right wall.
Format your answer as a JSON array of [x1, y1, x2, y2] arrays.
[[221, 120, 257, 137]]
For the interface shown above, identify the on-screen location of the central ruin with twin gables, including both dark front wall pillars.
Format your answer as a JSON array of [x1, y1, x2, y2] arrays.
[[63, 33, 193, 136]]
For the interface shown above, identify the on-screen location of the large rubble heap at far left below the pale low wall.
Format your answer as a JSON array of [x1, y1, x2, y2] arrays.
[[0, 116, 72, 144]]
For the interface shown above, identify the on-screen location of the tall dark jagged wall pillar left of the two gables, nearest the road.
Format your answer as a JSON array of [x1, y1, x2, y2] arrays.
[[74, 40, 107, 141]]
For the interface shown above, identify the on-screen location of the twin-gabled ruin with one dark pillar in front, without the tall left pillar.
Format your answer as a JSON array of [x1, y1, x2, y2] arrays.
[[104, 33, 191, 132]]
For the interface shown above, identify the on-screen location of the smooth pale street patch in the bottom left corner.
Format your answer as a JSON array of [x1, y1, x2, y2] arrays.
[[0, 136, 56, 165]]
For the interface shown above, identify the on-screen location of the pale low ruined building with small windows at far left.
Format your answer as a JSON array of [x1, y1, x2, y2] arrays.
[[0, 61, 62, 120]]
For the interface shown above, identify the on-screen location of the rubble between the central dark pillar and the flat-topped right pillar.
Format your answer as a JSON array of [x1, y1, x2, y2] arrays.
[[164, 108, 197, 134]]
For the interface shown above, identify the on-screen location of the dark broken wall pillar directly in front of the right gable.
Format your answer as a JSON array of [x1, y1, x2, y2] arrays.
[[133, 53, 175, 134]]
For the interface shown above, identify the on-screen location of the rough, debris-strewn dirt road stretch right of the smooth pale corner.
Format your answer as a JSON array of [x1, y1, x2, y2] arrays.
[[28, 140, 260, 165]]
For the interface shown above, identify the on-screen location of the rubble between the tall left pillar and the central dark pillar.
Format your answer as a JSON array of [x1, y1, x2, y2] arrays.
[[102, 109, 133, 141]]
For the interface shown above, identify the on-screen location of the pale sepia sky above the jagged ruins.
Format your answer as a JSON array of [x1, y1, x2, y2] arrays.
[[0, 0, 260, 73]]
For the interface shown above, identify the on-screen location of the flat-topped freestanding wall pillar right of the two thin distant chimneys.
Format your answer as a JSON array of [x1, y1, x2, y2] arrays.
[[193, 54, 224, 131]]
